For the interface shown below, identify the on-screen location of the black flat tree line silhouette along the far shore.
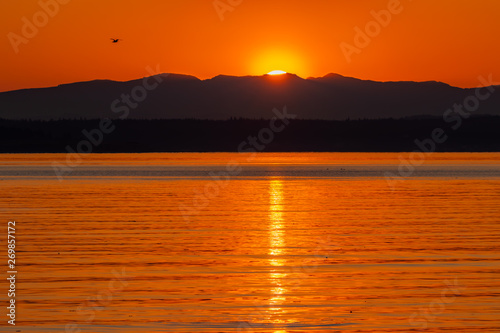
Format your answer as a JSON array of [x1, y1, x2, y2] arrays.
[[0, 116, 500, 153]]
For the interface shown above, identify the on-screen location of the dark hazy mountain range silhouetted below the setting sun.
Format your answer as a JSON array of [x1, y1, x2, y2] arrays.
[[0, 74, 500, 120]]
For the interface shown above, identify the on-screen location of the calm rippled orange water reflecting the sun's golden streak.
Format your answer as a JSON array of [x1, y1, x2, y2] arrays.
[[0, 153, 500, 333]]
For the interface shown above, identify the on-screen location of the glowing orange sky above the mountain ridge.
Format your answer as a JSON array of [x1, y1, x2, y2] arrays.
[[0, 0, 500, 91]]
